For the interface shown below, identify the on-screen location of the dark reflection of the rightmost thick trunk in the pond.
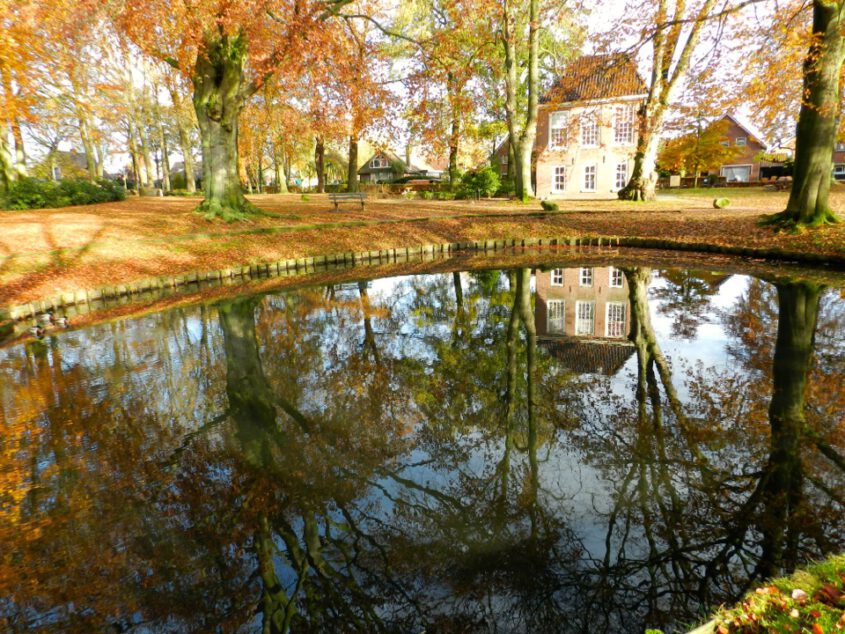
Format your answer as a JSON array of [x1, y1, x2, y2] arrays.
[[759, 283, 821, 577]]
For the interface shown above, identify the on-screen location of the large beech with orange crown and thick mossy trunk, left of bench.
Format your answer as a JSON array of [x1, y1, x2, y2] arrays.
[[115, 0, 346, 219]]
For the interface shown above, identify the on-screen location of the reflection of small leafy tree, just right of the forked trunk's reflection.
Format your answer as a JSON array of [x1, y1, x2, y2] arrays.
[[651, 269, 729, 340]]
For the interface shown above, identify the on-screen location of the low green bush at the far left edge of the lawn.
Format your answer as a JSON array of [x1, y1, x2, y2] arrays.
[[2, 178, 126, 210]]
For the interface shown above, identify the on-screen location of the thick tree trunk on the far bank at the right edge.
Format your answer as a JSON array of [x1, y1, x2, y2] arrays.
[[769, 0, 845, 227]]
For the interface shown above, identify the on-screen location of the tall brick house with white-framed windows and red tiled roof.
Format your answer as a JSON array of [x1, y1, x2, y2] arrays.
[[535, 55, 647, 199]]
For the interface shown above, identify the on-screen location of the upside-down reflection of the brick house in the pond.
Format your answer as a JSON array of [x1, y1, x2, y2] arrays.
[[534, 266, 634, 375]]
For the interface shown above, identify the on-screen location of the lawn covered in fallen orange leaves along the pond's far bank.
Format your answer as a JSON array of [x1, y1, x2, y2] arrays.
[[0, 188, 845, 306]]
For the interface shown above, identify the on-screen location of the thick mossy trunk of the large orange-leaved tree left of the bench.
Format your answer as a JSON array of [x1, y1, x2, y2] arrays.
[[191, 36, 252, 220]]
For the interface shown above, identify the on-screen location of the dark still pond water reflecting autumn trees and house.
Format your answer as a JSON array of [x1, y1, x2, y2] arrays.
[[0, 263, 845, 632]]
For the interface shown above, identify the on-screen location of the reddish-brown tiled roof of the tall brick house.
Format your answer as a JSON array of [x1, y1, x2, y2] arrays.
[[542, 54, 648, 103]]
